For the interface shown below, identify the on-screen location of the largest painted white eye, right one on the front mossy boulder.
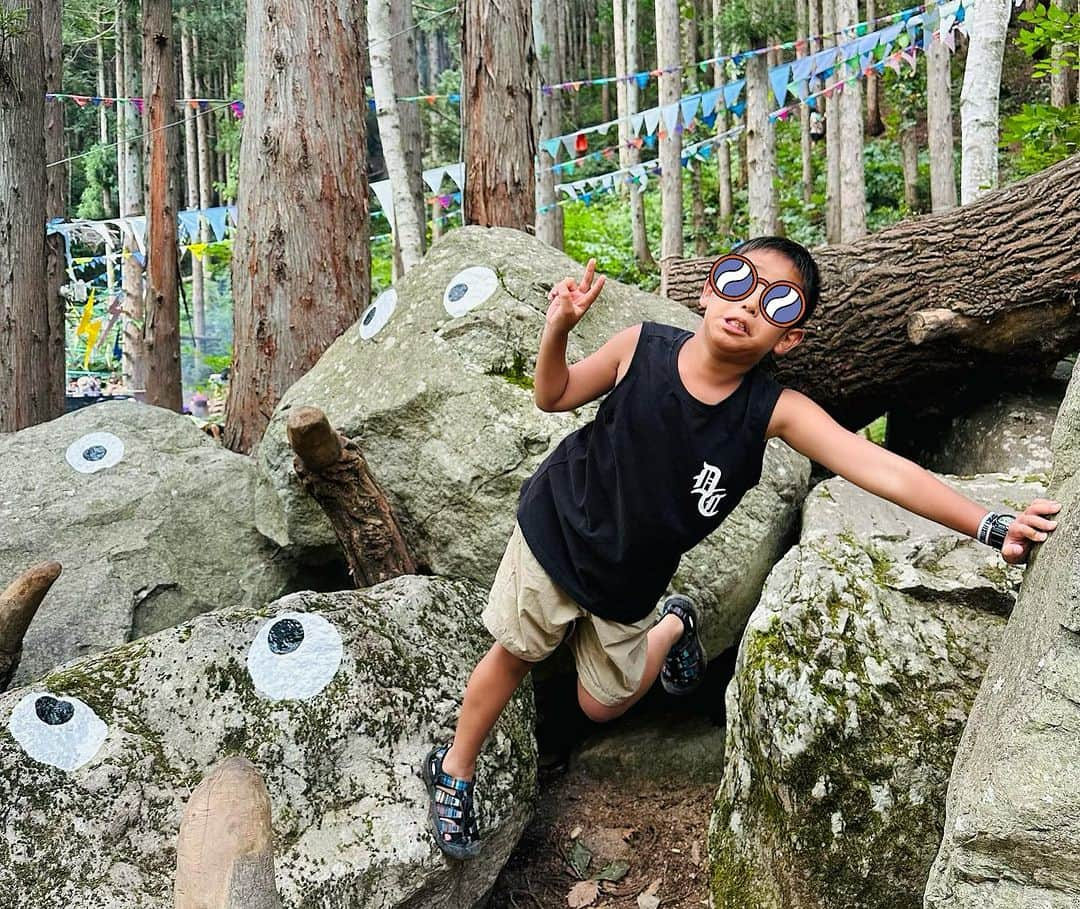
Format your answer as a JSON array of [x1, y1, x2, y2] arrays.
[[247, 612, 343, 701]]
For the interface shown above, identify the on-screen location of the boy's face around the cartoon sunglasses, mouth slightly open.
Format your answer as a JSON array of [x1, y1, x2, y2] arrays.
[[701, 249, 805, 363]]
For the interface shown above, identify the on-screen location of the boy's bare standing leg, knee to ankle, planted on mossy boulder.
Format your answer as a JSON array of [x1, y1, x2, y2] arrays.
[[443, 641, 533, 779]]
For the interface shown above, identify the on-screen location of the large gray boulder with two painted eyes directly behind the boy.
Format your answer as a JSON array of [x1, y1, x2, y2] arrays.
[[257, 227, 809, 652]]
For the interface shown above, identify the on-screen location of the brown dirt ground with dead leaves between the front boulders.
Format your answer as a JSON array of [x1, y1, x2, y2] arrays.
[[488, 766, 716, 909]]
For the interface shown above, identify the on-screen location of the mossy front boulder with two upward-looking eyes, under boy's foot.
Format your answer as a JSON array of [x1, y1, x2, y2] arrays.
[[0, 576, 536, 909]]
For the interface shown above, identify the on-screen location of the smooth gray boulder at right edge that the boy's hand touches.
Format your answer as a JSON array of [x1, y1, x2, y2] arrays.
[[926, 367, 1080, 909]]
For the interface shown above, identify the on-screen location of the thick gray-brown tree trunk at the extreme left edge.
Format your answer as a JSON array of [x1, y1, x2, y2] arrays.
[[0, 0, 53, 432]]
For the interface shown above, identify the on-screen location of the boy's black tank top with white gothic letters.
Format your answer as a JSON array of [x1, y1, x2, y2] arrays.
[[517, 322, 782, 623]]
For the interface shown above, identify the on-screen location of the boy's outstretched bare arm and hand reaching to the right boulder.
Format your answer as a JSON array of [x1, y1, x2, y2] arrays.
[[766, 389, 1061, 564]]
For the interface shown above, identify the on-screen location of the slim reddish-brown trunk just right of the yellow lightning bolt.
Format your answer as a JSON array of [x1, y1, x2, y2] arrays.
[[143, 0, 181, 411]]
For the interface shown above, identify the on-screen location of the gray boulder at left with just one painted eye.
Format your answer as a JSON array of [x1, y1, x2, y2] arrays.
[[0, 402, 292, 683]]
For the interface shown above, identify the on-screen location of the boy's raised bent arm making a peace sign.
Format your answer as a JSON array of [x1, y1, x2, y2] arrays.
[[532, 259, 640, 411]]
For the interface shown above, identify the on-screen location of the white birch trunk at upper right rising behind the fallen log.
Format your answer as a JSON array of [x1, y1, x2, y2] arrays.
[[963, 0, 1010, 205]]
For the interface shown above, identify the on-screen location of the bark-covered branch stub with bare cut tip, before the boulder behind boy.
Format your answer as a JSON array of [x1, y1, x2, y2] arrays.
[[286, 407, 416, 587]]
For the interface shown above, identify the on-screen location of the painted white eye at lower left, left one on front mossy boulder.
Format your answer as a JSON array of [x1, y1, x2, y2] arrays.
[[8, 691, 109, 772]]
